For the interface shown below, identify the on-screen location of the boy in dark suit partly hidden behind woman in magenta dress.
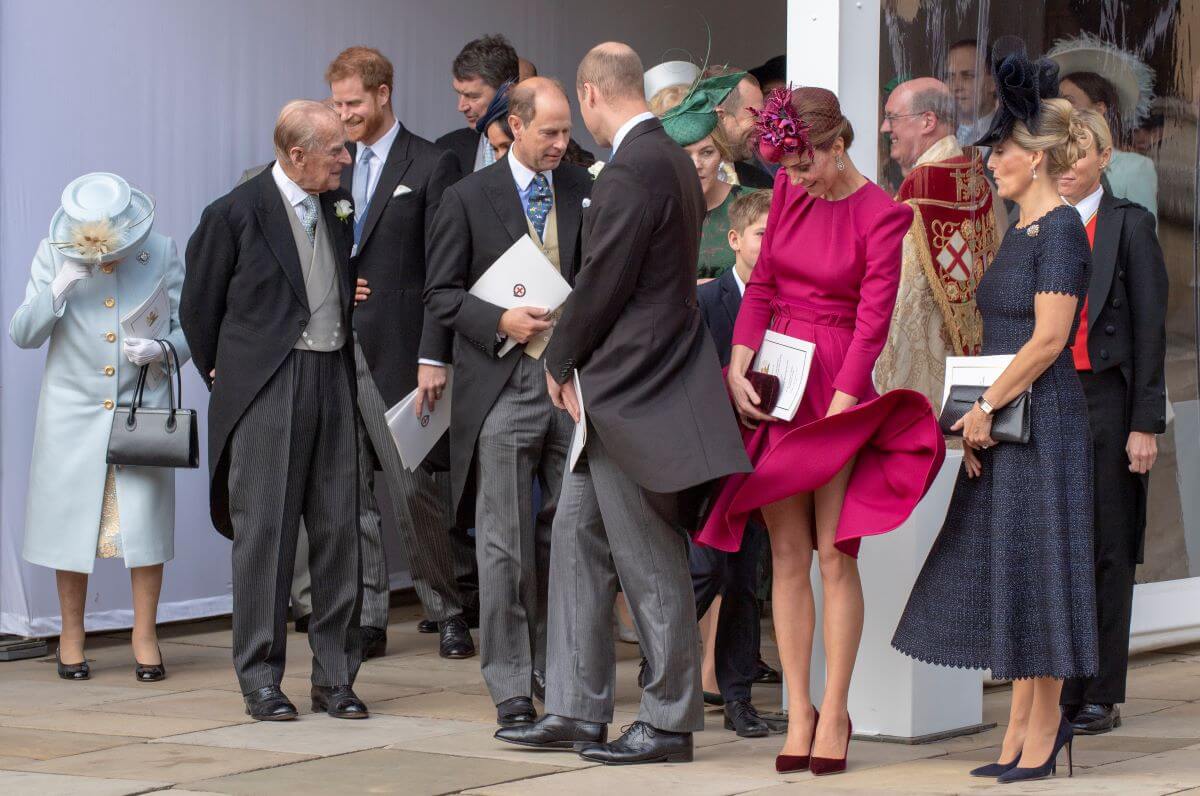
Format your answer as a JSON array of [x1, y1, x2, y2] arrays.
[[689, 191, 772, 737]]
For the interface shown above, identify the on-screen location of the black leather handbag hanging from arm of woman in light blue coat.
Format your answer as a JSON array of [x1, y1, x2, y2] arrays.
[[108, 340, 200, 467]]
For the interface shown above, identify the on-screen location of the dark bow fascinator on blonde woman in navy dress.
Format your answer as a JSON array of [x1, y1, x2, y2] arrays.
[[974, 36, 1058, 146]]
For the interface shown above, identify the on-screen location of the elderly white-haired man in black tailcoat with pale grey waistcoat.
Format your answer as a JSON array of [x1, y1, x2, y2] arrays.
[[180, 100, 367, 720]]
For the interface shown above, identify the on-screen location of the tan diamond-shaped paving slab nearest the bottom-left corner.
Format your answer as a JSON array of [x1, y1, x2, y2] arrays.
[[12, 743, 312, 784]]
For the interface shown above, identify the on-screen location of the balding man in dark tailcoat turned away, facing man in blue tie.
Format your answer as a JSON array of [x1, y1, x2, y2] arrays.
[[497, 42, 750, 764]]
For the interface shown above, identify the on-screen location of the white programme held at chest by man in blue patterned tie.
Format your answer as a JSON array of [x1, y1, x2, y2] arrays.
[[468, 234, 571, 357]]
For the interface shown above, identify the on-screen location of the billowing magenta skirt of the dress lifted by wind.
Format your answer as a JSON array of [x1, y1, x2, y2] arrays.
[[695, 299, 946, 557]]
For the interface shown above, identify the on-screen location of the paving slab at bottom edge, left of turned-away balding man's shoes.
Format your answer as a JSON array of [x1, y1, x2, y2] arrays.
[[194, 749, 563, 796]]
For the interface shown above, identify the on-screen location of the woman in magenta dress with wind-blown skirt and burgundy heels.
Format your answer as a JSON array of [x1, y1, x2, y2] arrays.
[[696, 88, 946, 774]]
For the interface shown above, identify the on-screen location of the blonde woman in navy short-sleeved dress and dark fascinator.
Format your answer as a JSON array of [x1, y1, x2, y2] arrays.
[[893, 55, 1097, 782]]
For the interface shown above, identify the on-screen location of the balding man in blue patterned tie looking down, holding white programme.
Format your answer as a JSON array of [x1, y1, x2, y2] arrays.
[[420, 77, 592, 726]]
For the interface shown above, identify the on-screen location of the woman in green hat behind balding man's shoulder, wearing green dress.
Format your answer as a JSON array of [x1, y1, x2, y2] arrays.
[[650, 72, 745, 282]]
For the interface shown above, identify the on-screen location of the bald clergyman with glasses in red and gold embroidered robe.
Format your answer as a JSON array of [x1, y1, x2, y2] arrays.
[[875, 77, 1004, 407]]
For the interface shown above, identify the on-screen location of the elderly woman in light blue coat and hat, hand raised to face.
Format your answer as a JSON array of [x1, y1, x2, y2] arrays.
[[8, 175, 188, 682]]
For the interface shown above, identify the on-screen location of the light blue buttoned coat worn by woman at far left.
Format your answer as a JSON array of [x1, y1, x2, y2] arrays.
[[8, 232, 190, 573]]
